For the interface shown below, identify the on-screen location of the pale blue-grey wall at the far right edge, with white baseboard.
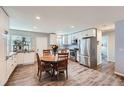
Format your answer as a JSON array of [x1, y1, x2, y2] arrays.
[[115, 20, 124, 76]]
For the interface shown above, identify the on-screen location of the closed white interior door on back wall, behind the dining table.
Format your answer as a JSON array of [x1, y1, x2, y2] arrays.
[[36, 37, 48, 54]]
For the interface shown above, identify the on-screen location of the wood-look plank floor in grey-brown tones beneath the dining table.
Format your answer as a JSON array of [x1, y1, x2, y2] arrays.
[[6, 61, 124, 86]]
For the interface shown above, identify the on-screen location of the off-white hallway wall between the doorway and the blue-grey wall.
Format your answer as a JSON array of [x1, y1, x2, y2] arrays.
[[103, 31, 115, 62]]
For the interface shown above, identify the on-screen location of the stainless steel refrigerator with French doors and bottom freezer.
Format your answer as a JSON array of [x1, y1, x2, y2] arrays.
[[79, 37, 97, 68]]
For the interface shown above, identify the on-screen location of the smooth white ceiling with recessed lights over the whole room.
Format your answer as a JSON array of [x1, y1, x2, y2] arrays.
[[4, 6, 124, 33]]
